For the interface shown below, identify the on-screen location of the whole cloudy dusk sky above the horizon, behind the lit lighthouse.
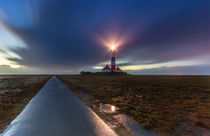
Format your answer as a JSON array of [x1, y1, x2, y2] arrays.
[[0, 0, 210, 75]]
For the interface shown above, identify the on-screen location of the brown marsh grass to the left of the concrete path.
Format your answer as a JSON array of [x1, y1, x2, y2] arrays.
[[0, 75, 50, 133]]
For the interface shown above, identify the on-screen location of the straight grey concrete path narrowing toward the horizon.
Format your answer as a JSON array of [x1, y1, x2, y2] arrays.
[[1, 77, 116, 136]]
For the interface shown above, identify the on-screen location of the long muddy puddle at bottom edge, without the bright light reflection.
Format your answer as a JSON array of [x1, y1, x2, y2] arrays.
[[113, 114, 156, 136]]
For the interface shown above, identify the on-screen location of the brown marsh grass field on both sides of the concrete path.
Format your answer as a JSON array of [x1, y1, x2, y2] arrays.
[[0, 75, 210, 136]]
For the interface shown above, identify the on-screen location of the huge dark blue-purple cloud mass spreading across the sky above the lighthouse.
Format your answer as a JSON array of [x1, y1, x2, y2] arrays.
[[0, 0, 210, 69]]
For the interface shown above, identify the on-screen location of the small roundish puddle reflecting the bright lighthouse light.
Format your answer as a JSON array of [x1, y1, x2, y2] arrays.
[[99, 103, 119, 113]]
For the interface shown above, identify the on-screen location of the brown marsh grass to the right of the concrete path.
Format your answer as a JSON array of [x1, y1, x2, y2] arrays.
[[58, 75, 210, 136]]
